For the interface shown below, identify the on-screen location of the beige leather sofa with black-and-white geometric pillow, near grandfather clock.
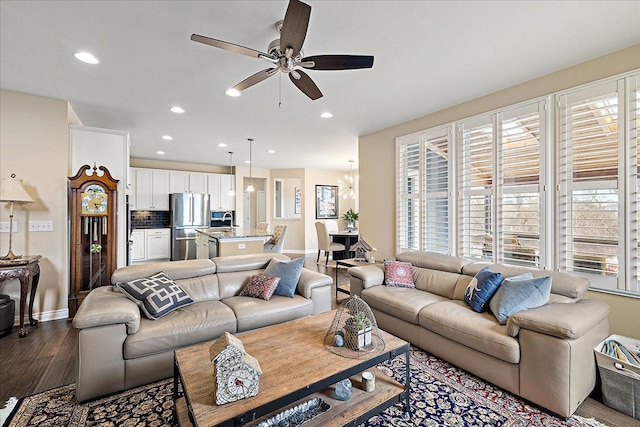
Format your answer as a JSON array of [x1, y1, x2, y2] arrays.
[[73, 254, 332, 401]]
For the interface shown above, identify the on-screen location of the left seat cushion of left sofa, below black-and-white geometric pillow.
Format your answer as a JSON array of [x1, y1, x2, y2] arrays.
[[124, 300, 238, 359]]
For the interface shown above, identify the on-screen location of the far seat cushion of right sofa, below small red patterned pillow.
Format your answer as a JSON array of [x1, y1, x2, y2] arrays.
[[361, 286, 447, 325]]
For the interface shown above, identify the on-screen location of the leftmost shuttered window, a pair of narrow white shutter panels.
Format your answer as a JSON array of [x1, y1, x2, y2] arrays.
[[396, 127, 452, 253]]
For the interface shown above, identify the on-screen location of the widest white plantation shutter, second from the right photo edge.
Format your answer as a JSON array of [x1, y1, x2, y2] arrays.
[[558, 82, 620, 288]]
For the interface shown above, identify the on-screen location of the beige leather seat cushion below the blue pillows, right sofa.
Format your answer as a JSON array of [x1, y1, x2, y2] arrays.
[[418, 301, 520, 363]]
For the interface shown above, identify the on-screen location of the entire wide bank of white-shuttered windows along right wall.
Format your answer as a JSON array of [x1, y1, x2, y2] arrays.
[[396, 70, 640, 296]]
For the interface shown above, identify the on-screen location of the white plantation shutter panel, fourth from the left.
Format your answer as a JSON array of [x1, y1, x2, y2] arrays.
[[495, 102, 545, 267]]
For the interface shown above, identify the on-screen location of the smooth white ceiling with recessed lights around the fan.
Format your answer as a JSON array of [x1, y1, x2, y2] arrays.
[[0, 0, 640, 170]]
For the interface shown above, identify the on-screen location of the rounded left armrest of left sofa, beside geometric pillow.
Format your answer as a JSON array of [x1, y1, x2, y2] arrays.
[[72, 286, 140, 334]]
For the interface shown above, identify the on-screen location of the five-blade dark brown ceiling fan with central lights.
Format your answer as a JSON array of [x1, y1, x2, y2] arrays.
[[191, 0, 373, 100]]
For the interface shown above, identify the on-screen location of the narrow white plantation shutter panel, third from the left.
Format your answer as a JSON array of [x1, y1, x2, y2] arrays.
[[458, 116, 495, 259]]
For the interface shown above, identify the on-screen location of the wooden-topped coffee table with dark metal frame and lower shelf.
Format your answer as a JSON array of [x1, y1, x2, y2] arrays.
[[174, 311, 410, 427]]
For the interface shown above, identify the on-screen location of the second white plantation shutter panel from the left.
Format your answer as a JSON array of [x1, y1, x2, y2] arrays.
[[420, 127, 451, 254]]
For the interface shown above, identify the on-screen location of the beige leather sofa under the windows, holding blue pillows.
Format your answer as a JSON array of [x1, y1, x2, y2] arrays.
[[349, 252, 609, 417]]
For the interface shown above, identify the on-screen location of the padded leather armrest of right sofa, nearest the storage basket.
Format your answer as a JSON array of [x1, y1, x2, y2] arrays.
[[507, 299, 609, 339]]
